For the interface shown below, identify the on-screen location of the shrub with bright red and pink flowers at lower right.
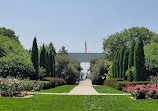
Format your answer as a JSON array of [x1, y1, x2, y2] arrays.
[[122, 84, 158, 99]]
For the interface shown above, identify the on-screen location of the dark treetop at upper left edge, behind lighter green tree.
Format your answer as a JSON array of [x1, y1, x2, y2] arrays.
[[0, 27, 19, 43]]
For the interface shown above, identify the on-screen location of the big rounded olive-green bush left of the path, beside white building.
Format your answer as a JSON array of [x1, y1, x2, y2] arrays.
[[55, 54, 82, 84]]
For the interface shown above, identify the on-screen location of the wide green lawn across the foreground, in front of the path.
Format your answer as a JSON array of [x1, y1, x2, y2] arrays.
[[0, 95, 158, 111]]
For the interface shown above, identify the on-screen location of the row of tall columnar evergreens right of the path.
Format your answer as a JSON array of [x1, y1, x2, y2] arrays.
[[112, 37, 146, 81]]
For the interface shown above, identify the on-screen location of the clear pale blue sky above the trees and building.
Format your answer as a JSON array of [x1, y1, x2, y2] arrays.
[[0, 0, 158, 52]]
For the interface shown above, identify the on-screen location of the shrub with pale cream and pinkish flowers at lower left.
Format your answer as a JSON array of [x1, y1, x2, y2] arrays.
[[0, 77, 42, 97]]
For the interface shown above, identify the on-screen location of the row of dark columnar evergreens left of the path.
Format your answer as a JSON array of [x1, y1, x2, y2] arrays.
[[31, 37, 55, 80]]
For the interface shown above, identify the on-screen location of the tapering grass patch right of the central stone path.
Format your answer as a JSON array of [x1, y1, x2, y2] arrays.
[[93, 85, 124, 93]]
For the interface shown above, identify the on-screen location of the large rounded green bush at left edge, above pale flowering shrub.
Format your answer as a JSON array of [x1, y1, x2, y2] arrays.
[[0, 53, 34, 77]]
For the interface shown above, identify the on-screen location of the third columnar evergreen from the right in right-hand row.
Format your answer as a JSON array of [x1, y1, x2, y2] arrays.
[[122, 49, 129, 80]]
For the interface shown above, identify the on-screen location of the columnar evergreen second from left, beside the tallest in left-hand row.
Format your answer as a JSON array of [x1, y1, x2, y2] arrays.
[[40, 44, 46, 68]]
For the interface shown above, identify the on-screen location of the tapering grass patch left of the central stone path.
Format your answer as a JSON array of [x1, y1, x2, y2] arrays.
[[36, 85, 76, 93]]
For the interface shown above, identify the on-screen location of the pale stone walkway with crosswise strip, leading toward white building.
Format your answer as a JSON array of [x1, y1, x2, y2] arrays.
[[29, 79, 131, 95]]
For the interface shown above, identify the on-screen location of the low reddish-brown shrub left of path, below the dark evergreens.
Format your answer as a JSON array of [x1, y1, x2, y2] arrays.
[[43, 77, 66, 87]]
